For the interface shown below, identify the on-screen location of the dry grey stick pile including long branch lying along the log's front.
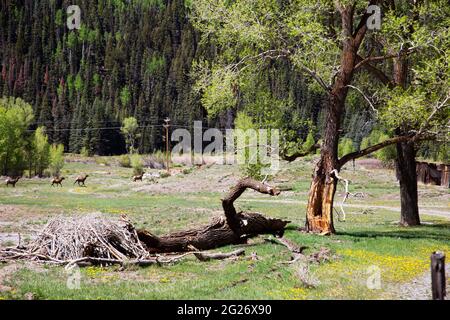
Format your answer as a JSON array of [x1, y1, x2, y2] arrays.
[[0, 215, 250, 266]]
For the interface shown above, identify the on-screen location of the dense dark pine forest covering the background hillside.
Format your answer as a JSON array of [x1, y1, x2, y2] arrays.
[[0, 0, 371, 155]]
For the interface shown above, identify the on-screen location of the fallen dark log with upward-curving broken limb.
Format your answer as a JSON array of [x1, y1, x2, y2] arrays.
[[137, 178, 290, 253]]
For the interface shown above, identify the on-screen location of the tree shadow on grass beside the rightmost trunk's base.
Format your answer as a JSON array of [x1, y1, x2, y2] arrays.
[[336, 223, 450, 241]]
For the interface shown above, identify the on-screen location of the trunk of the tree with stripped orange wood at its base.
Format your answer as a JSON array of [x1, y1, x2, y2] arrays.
[[306, 5, 367, 234]]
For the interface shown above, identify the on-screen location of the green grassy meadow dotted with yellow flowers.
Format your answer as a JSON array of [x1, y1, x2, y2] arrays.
[[0, 158, 450, 299]]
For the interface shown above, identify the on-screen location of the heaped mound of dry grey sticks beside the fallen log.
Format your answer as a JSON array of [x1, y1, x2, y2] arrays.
[[0, 215, 150, 264]]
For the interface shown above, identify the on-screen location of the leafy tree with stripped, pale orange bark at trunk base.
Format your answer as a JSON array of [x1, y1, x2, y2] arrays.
[[192, 0, 448, 234]]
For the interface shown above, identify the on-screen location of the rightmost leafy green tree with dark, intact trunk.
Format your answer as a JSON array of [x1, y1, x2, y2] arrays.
[[342, 1, 450, 226]]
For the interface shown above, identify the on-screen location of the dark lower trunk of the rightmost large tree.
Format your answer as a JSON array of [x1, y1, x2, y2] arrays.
[[395, 142, 420, 226]]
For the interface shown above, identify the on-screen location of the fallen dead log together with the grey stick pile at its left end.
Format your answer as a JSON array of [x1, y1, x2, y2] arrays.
[[0, 178, 289, 265]]
